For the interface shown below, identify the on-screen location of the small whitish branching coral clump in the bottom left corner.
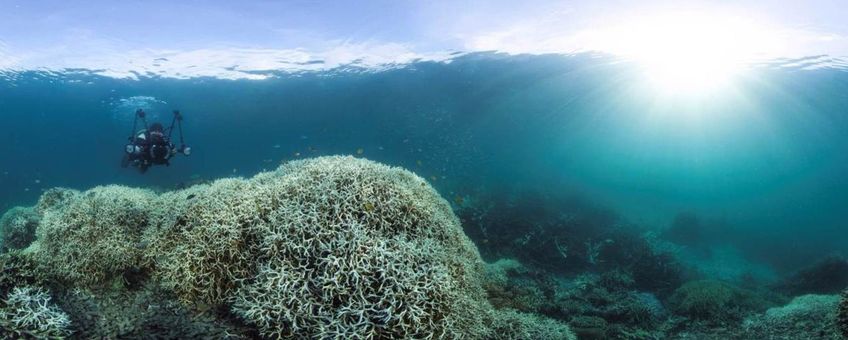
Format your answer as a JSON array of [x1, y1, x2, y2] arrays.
[[0, 286, 71, 338]]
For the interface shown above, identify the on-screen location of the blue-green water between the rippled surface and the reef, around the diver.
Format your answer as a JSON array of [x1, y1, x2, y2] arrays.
[[0, 53, 848, 271]]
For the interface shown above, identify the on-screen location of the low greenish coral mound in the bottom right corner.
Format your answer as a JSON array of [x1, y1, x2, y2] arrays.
[[741, 295, 841, 340]]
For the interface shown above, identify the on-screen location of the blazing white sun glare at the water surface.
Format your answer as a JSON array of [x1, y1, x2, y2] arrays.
[[594, 12, 780, 94]]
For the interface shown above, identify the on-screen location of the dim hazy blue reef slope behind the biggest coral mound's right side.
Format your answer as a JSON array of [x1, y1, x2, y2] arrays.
[[458, 189, 684, 295]]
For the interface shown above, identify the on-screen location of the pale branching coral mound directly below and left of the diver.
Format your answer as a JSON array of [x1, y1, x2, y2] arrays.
[[32, 186, 156, 286]]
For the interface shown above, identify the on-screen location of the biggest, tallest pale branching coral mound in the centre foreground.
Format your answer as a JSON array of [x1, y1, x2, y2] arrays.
[[234, 157, 490, 338]]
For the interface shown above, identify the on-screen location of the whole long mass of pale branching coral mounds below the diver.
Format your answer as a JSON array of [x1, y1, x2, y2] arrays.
[[0, 157, 573, 339]]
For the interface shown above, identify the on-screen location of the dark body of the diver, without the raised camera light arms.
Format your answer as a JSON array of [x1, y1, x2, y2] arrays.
[[121, 128, 175, 173]]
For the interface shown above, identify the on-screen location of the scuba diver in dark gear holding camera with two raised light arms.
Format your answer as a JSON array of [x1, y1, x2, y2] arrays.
[[121, 109, 191, 173]]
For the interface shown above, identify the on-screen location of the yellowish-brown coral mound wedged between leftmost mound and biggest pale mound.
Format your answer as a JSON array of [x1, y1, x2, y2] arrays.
[[143, 179, 272, 305]]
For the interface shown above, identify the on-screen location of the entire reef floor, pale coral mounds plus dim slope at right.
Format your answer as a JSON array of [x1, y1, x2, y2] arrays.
[[0, 156, 848, 339]]
